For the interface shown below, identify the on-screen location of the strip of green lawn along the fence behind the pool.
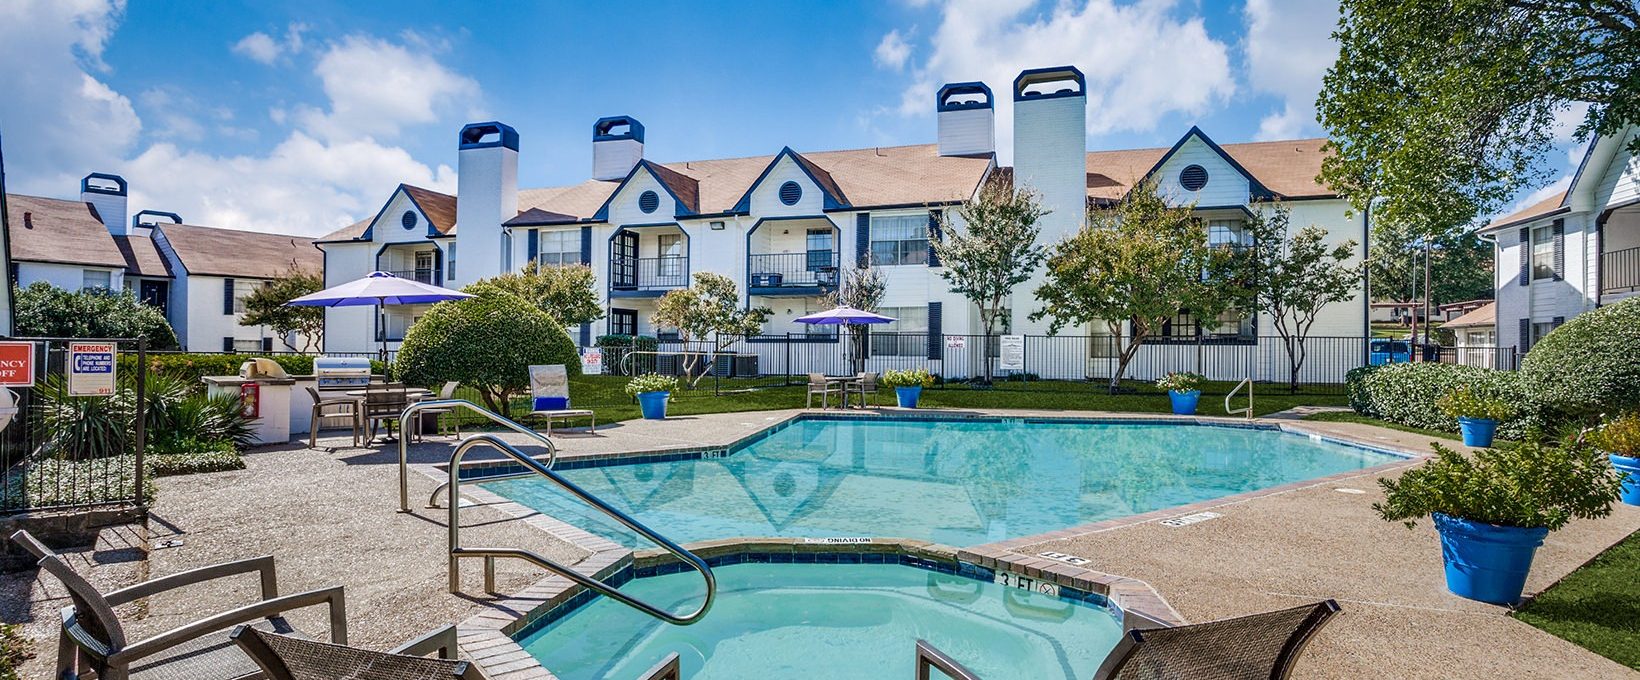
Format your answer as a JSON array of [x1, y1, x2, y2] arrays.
[[461, 375, 1346, 423]]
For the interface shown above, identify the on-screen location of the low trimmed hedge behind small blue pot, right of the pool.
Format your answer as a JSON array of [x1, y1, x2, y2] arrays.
[[1345, 364, 1537, 439]]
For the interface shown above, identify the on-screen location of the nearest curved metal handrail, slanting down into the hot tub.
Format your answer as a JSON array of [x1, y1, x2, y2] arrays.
[[448, 433, 717, 626]]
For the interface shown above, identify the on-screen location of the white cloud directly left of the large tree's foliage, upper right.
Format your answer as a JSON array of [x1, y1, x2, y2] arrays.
[[1243, 0, 1338, 139]]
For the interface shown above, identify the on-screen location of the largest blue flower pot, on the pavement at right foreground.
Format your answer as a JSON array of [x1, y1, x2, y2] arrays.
[[1435, 513, 1548, 605]]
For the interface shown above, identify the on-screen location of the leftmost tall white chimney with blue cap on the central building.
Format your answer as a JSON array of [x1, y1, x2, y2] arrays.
[[449, 121, 518, 287]]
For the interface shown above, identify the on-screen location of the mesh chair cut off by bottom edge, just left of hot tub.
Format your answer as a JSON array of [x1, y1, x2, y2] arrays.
[[228, 626, 487, 680]]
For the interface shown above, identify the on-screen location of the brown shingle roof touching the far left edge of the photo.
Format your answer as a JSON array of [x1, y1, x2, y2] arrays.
[[7, 193, 125, 267]]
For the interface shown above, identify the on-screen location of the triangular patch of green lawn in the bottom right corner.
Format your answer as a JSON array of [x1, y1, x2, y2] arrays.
[[1515, 533, 1640, 670]]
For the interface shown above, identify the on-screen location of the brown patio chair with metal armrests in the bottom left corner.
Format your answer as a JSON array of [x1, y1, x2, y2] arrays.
[[11, 531, 348, 680]]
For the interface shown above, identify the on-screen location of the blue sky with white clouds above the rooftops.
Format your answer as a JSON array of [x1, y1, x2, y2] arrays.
[[0, 0, 1587, 234]]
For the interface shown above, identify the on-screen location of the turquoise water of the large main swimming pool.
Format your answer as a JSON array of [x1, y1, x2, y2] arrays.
[[485, 418, 1396, 547]]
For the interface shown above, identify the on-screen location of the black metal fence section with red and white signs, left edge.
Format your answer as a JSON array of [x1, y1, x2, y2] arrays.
[[0, 338, 149, 516]]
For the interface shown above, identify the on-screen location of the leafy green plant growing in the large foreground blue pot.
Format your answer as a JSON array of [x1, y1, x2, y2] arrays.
[[1373, 439, 1622, 531]]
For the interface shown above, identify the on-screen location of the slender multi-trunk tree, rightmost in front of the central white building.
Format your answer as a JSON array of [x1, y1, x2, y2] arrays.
[[1245, 205, 1361, 392]]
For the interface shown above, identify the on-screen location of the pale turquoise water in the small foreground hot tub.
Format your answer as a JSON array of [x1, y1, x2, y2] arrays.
[[520, 564, 1122, 680]]
